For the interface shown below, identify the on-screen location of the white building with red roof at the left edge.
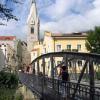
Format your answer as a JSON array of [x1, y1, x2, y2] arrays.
[[0, 36, 16, 69]]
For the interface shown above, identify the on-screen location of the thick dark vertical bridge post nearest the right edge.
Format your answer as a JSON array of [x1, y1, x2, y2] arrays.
[[89, 59, 95, 100]]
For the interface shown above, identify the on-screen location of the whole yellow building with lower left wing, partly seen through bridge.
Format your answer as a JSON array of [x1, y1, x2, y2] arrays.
[[31, 31, 87, 76]]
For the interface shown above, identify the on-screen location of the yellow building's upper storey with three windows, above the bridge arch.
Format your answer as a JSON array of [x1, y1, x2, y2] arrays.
[[43, 32, 87, 53]]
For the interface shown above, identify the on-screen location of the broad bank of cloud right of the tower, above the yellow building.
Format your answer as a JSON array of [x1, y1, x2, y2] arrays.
[[41, 0, 100, 32]]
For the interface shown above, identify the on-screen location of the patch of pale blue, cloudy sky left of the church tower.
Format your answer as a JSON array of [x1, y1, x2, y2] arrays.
[[0, 0, 30, 40]]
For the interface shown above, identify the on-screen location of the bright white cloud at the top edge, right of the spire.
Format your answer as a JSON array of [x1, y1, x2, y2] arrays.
[[41, 0, 74, 19]]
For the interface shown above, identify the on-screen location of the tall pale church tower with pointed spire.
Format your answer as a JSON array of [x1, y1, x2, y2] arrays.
[[27, 0, 39, 52]]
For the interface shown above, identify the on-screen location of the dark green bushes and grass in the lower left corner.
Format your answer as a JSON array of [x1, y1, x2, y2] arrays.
[[0, 71, 23, 100]]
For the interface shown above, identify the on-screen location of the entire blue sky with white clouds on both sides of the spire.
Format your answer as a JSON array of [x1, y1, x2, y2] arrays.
[[0, 0, 100, 39]]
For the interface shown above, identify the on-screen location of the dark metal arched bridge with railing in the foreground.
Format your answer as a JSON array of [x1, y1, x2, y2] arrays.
[[19, 52, 100, 100]]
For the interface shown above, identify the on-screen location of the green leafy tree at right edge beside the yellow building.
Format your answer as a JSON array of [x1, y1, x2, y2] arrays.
[[86, 27, 100, 53]]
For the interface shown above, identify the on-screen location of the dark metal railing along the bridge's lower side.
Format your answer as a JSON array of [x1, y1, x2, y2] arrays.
[[20, 73, 100, 100]]
